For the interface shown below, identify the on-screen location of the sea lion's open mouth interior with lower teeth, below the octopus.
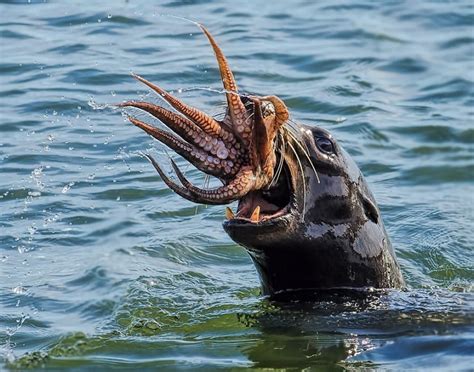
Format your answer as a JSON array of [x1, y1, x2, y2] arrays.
[[224, 158, 295, 227]]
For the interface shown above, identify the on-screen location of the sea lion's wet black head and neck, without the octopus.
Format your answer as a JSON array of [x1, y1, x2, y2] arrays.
[[224, 126, 404, 296]]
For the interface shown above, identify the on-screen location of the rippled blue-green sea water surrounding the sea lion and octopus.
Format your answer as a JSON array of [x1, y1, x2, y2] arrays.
[[0, 0, 474, 371]]
